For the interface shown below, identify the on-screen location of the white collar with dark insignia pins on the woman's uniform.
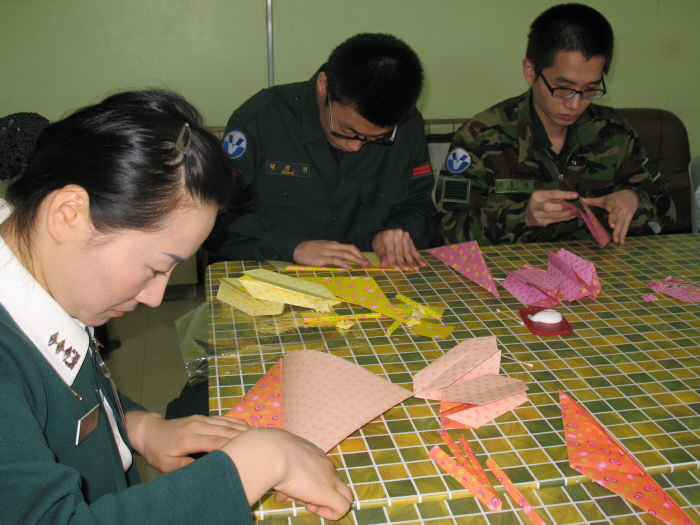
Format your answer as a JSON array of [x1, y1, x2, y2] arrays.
[[0, 199, 90, 386]]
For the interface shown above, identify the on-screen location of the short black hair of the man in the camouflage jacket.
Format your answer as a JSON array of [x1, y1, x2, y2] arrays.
[[525, 4, 614, 75]]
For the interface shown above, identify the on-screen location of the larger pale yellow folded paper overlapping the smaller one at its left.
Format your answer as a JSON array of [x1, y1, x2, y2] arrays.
[[238, 269, 339, 312]]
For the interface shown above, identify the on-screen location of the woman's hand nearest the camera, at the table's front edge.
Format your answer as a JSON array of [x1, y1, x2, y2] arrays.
[[221, 428, 352, 520]]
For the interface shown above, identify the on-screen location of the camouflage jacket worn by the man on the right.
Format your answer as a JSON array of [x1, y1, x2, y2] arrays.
[[434, 91, 676, 245]]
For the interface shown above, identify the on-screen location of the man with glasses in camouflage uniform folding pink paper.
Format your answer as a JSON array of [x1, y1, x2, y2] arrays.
[[434, 4, 675, 245]]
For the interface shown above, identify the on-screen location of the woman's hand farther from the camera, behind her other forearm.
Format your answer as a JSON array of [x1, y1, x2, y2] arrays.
[[125, 410, 250, 473]]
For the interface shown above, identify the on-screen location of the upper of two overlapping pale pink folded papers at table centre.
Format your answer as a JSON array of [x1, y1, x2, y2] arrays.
[[413, 335, 501, 401]]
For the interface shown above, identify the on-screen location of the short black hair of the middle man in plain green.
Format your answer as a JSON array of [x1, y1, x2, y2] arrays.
[[323, 33, 423, 128]]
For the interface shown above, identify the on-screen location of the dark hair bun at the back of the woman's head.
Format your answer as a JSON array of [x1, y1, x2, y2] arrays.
[[0, 113, 49, 180]]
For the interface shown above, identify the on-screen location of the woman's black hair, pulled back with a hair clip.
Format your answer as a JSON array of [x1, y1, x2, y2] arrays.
[[1, 90, 232, 245]]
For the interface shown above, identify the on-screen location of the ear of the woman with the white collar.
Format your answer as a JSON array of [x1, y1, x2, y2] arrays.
[[46, 184, 92, 243]]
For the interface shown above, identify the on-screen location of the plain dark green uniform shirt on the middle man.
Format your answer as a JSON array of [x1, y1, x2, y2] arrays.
[[205, 69, 436, 261]]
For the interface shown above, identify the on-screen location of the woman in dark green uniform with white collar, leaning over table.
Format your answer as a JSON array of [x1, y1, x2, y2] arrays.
[[0, 90, 352, 525]]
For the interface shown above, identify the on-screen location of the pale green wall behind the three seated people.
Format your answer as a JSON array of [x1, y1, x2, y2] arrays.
[[0, 0, 700, 155]]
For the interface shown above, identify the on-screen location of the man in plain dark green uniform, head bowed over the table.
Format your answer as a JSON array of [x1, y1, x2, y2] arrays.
[[205, 34, 436, 269]]
